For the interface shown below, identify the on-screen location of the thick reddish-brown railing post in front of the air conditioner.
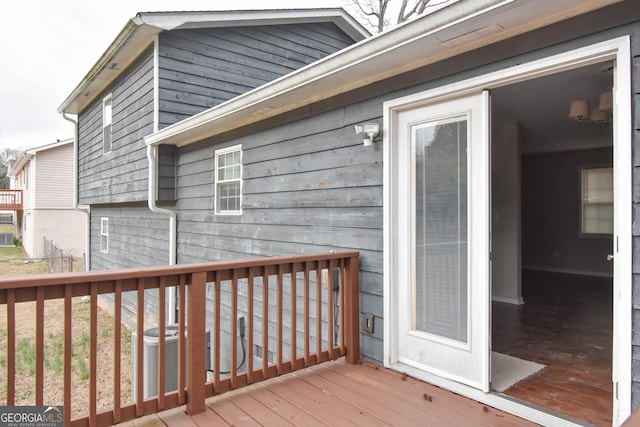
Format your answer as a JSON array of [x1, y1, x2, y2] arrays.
[[187, 272, 207, 415]]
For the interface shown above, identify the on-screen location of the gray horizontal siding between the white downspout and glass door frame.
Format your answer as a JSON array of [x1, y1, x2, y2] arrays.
[[176, 96, 383, 361]]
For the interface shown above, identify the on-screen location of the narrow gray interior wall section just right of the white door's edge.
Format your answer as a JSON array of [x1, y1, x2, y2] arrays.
[[491, 118, 522, 304]]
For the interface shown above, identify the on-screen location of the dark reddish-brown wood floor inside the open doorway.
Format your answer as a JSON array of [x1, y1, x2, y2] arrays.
[[492, 271, 613, 426]]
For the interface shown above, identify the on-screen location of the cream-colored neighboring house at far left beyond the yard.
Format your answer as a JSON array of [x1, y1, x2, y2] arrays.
[[8, 139, 87, 258]]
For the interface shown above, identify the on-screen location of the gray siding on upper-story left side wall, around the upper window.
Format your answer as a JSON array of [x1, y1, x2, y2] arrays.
[[78, 50, 153, 204]]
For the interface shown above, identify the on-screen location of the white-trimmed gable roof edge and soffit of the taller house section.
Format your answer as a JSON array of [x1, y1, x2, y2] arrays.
[[58, 8, 370, 114]]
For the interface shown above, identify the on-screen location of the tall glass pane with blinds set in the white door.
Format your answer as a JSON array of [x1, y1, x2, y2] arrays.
[[411, 116, 468, 343]]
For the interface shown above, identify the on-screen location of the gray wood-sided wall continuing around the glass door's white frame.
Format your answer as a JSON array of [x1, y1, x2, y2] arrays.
[[168, 5, 640, 382]]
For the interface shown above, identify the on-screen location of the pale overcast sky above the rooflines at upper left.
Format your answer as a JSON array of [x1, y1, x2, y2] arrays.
[[0, 0, 348, 154]]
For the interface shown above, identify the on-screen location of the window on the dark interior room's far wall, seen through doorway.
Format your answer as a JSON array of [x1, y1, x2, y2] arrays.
[[580, 167, 613, 235]]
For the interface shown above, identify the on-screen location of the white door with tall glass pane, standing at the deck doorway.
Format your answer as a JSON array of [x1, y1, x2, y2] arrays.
[[391, 91, 491, 391]]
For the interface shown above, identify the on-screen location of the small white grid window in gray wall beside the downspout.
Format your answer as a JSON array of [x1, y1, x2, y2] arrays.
[[215, 145, 242, 215]]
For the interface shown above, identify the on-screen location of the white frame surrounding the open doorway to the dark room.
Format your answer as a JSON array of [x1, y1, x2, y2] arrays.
[[383, 36, 633, 426]]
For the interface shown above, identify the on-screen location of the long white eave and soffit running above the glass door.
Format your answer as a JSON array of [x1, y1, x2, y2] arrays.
[[145, 0, 620, 146]]
